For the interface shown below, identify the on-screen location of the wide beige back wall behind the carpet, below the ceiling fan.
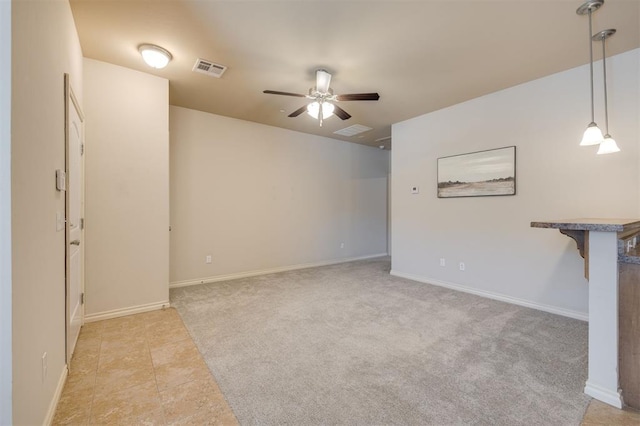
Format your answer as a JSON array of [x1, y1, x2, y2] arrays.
[[170, 107, 388, 284]]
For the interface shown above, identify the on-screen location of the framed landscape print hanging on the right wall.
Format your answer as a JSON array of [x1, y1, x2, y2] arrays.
[[438, 146, 516, 198]]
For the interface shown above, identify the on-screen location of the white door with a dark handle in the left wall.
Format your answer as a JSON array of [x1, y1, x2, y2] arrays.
[[65, 74, 84, 365]]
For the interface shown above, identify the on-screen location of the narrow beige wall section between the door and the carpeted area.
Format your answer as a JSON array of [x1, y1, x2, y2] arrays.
[[84, 59, 169, 320]]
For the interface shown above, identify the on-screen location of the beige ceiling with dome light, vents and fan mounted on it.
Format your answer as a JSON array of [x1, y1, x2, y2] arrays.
[[71, 0, 640, 148]]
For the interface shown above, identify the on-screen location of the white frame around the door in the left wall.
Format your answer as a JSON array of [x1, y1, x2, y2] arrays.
[[64, 73, 85, 366]]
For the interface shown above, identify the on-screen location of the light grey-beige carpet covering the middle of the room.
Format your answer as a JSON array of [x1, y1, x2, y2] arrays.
[[171, 259, 590, 425]]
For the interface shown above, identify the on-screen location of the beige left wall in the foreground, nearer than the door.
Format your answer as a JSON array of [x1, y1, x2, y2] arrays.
[[11, 1, 82, 425]]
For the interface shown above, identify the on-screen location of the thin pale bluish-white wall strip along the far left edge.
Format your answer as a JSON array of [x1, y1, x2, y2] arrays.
[[0, 1, 12, 425]]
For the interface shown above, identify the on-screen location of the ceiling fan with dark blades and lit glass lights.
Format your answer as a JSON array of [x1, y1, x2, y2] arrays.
[[263, 69, 380, 126]]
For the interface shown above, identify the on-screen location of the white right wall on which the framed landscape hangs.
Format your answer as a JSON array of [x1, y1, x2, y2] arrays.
[[392, 50, 640, 318]]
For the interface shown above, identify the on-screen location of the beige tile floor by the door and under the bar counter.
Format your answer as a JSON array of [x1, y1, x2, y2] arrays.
[[53, 308, 640, 426]]
